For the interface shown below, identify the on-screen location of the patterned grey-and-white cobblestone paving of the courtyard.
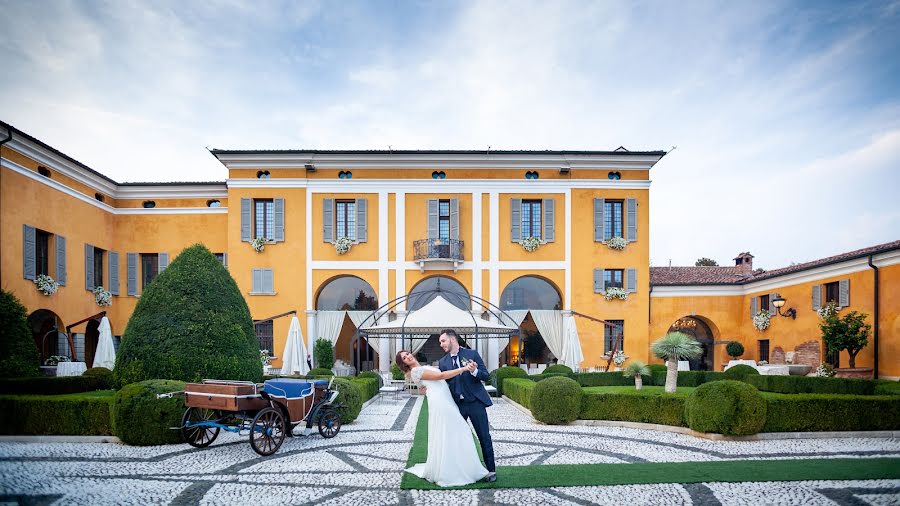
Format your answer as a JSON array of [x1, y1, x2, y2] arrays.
[[0, 398, 900, 506]]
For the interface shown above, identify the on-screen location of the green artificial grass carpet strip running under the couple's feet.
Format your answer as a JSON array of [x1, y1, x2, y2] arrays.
[[400, 398, 900, 490]]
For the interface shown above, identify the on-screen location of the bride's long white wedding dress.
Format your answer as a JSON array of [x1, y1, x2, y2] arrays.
[[406, 366, 488, 487]]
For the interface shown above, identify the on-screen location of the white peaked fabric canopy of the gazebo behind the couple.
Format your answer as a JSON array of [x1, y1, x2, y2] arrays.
[[360, 295, 519, 335]]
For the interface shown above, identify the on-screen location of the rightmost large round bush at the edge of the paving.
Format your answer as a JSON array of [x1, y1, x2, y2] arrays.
[[684, 380, 766, 436]]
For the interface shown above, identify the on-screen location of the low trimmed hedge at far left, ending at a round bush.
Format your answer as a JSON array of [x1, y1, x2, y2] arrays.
[[0, 390, 115, 436]]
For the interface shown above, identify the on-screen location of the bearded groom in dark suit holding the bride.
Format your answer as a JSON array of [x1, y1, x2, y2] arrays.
[[438, 329, 497, 482]]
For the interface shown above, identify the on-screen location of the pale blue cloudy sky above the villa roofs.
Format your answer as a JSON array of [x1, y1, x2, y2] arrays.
[[0, 0, 900, 268]]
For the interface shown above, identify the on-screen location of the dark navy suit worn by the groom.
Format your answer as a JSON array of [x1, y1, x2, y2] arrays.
[[438, 348, 495, 472]]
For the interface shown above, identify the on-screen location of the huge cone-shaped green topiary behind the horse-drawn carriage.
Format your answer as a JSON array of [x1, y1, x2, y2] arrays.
[[115, 244, 262, 385]]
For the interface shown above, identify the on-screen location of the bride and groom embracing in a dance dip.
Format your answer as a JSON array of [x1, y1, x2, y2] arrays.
[[397, 329, 497, 487]]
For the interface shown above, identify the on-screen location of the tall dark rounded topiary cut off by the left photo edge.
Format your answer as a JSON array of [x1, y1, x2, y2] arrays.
[[0, 290, 41, 378]]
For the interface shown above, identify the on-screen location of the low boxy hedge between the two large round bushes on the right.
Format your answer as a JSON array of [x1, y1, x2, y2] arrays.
[[578, 386, 688, 426]]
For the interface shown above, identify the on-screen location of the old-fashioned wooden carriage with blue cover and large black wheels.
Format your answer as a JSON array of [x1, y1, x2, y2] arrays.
[[163, 378, 341, 456]]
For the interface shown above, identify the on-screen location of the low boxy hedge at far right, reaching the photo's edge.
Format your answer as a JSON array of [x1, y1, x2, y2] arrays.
[[762, 392, 900, 432]]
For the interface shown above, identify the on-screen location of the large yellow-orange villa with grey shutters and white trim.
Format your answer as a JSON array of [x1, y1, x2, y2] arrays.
[[0, 119, 900, 377]]
